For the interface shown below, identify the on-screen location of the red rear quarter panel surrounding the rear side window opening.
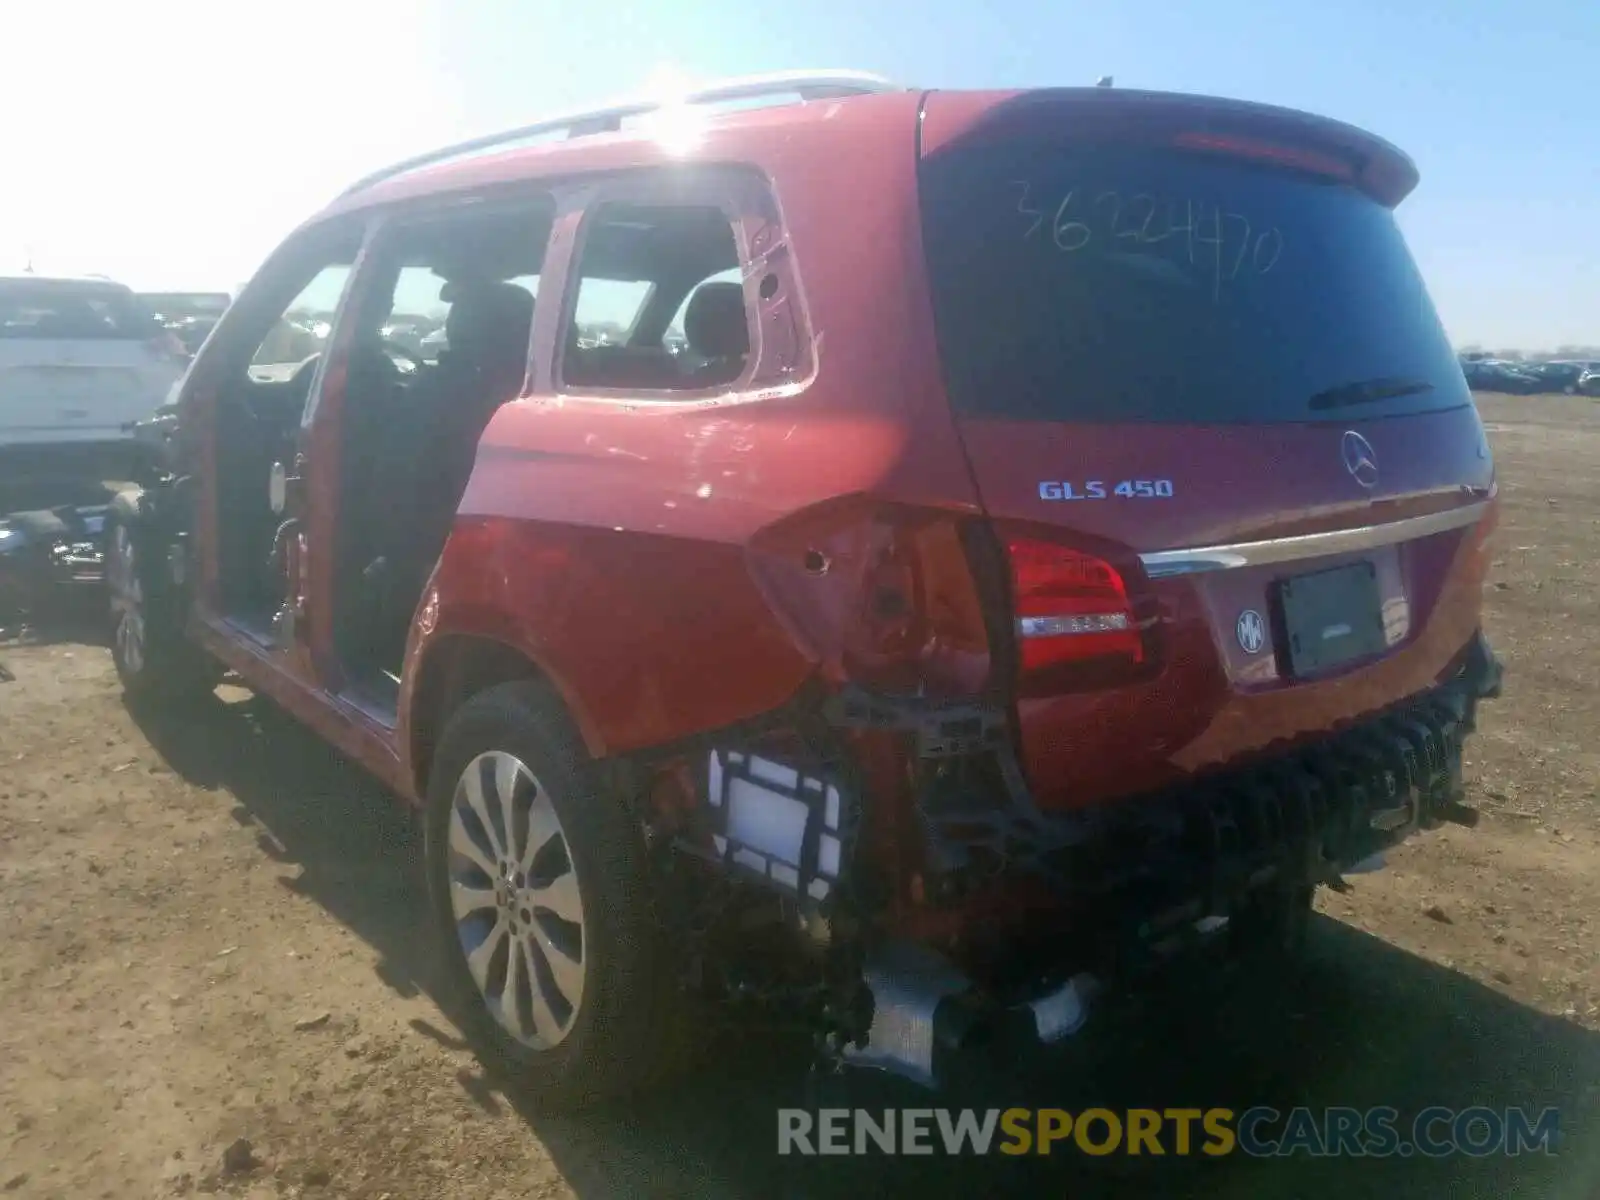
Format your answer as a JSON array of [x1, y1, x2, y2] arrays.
[[402, 94, 978, 780]]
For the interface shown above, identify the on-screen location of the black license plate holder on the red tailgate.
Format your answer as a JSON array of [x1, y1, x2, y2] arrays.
[[1277, 560, 1389, 675]]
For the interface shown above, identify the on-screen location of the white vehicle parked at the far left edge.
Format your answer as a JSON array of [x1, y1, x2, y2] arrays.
[[0, 278, 182, 446]]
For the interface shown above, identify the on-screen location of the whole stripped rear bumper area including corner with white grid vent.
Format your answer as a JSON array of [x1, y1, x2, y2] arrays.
[[649, 635, 1502, 1085]]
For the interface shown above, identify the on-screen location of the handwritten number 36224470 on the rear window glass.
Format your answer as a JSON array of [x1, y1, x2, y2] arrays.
[[1013, 179, 1283, 297]]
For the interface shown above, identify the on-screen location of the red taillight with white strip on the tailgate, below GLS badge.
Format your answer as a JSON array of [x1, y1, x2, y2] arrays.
[[1006, 538, 1144, 674]]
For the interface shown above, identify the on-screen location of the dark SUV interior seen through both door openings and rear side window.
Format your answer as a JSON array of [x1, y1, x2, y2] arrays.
[[219, 193, 749, 710]]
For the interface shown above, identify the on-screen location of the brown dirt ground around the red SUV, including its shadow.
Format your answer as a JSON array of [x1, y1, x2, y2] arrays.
[[0, 397, 1600, 1200]]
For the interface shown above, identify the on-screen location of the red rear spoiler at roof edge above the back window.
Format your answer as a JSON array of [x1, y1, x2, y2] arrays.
[[922, 88, 1419, 208]]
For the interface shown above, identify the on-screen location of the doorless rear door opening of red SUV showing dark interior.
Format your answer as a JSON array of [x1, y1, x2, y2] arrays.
[[334, 203, 550, 701]]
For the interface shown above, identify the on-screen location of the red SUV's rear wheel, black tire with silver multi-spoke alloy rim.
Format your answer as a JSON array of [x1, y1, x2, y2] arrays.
[[426, 682, 685, 1110]]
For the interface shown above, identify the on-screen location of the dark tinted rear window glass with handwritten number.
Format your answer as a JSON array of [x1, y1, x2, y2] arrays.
[[922, 142, 1470, 422]]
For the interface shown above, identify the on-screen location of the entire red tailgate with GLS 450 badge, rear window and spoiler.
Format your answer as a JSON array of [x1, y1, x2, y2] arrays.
[[922, 91, 1493, 803]]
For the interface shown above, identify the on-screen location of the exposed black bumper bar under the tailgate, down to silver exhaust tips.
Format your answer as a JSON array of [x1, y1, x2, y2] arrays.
[[838, 634, 1502, 1086]]
